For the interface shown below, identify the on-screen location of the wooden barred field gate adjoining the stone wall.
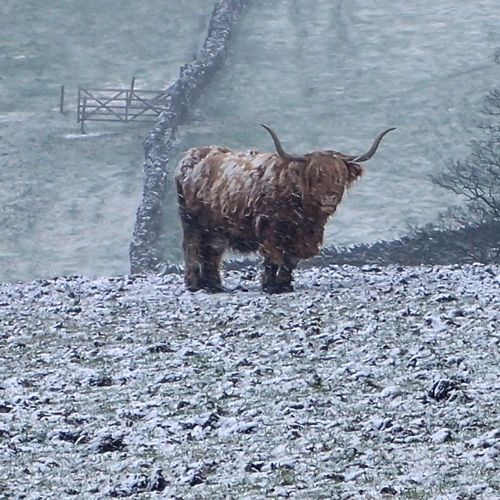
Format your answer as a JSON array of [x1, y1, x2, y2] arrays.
[[77, 78, 167, 132]]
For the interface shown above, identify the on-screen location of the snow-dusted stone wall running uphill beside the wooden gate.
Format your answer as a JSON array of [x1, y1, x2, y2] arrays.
[[130, 0, 250, 274]]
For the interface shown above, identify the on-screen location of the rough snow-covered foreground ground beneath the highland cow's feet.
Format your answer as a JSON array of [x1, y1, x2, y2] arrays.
[[0, 265, 500, 500]]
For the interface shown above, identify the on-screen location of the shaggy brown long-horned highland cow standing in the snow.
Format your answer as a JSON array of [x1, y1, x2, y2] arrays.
[[175, 127, 392, 293]]
